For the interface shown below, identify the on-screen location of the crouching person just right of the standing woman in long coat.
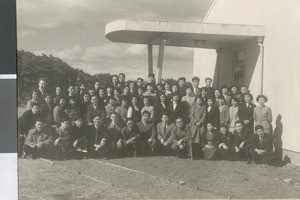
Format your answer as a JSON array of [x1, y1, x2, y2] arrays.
[[202, 123, 219, 160]]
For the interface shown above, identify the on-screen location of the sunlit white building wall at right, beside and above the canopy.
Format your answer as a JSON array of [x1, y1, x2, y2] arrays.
[[194, 0, 300, 152]]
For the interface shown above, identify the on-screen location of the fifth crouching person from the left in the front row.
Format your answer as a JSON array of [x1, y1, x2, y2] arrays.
[[106, 112, 123, 157]]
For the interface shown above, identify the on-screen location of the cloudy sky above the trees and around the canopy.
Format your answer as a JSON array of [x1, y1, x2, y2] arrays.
[[17, 0, 213, 80]]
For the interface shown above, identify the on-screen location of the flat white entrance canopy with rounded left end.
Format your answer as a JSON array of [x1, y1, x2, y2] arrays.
[[105, 19, 264, 49]]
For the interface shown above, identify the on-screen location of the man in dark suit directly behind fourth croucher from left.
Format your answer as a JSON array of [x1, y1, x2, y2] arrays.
[[86, 95, 106, 125]]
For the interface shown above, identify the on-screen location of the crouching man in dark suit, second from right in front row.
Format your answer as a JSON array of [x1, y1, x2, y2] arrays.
[[233, 120, 252, 163]]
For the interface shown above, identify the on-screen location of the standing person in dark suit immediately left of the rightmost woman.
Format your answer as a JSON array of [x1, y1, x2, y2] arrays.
[[238, 94, 255, 133]]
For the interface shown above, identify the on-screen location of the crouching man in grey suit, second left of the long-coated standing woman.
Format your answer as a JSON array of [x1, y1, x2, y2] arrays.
[[157, 114, 175, 154]]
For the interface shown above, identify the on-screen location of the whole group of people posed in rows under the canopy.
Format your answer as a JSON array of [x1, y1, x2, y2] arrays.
[[18, 73, 273, 163]]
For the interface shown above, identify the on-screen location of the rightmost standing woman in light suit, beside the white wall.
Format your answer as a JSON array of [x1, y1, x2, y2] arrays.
[[253, 95, 272, 134]]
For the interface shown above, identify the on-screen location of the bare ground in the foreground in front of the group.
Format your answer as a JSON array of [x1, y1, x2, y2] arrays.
[[19, 156, 300, 199]]
